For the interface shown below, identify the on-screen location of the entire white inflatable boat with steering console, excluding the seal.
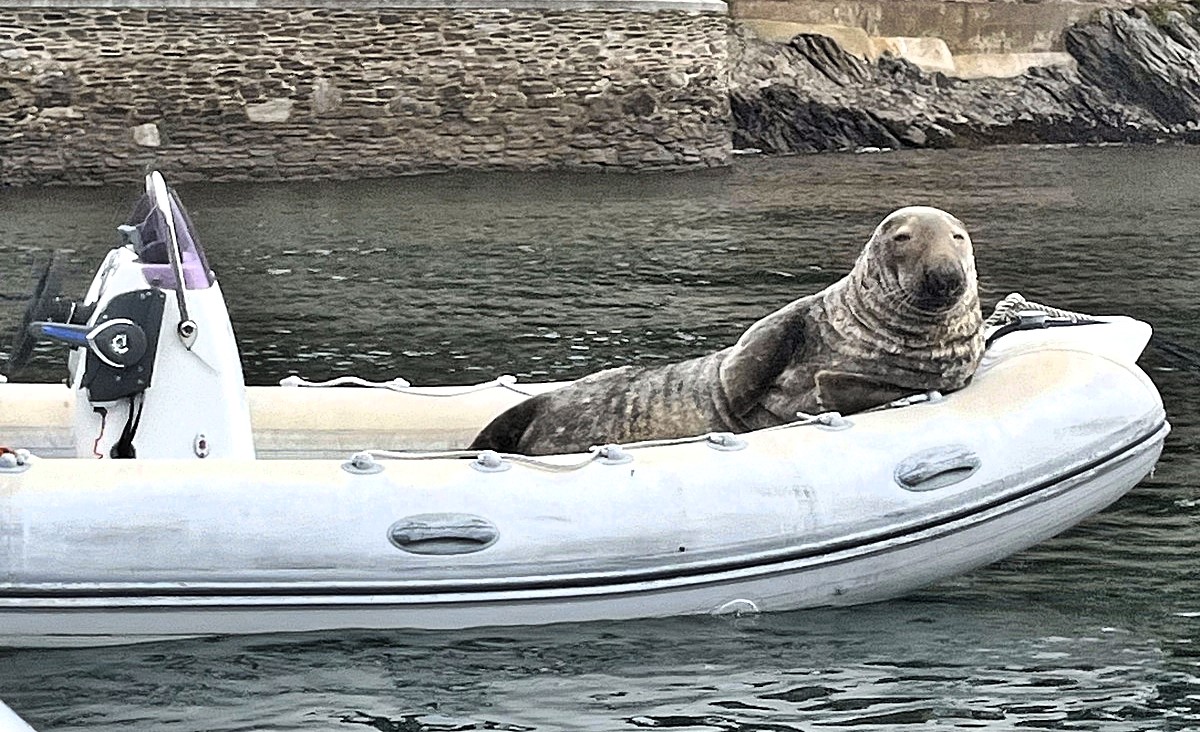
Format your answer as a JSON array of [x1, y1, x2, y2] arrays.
[[0, 174, 1169, 646]]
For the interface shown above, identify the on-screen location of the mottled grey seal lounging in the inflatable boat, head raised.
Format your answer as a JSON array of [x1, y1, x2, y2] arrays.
[[470, 206, 984, 455]]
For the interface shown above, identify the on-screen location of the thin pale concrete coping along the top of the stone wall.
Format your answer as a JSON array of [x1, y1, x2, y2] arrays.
[[0, 0, 728, 14]]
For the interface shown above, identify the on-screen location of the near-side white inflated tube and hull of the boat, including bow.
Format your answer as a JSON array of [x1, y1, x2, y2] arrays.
[[0, 319, 1169, 646]]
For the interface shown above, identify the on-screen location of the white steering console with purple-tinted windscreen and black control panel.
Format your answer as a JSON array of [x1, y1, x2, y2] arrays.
[[21, 172, 254, 458]]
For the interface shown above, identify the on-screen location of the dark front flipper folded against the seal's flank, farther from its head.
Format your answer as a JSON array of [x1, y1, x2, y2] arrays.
[[719, 300, 804, 418]]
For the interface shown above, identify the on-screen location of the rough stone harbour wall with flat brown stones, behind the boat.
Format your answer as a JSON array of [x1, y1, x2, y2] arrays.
[[0, 0, 731, 185]]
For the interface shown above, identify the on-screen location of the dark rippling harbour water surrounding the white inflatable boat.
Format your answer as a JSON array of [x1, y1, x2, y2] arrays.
[[0, 148, 1200, 732]]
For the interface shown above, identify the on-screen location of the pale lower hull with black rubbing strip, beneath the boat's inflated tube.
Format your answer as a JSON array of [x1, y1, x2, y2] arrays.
[[0, 425, 1169, 647]]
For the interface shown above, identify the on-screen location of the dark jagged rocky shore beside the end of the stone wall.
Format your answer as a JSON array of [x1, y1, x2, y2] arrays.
[[730, 5, 1200, 154]]
